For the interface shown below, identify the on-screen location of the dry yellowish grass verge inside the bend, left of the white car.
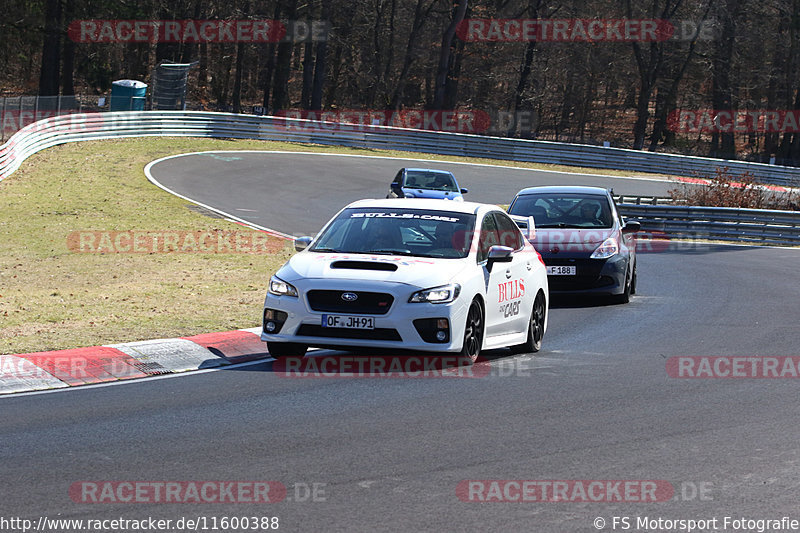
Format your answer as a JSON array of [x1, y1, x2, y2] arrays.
[[0, 138, 664, 354]]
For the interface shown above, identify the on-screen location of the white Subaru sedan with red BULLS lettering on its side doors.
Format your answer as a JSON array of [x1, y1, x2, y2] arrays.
[[261, 199, 549, 364]]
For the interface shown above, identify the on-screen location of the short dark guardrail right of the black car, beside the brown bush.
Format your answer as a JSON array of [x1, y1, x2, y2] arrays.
[[618, 204, 800, 246]]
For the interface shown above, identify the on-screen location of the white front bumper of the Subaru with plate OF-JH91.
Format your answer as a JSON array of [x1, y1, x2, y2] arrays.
[[261, 279, 469, 352]]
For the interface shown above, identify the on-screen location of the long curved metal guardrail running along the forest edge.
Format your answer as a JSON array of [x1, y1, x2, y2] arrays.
[[0, 111, 800, 186]]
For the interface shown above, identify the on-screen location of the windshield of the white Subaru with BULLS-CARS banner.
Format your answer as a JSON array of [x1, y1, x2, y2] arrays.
[[310, 207, 475, 258]]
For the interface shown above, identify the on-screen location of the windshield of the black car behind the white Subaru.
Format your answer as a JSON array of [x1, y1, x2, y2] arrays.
[[508, 193, 613, 228]]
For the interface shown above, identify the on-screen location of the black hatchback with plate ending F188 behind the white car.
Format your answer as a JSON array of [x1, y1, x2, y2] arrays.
[[508, 186, 640, 303]]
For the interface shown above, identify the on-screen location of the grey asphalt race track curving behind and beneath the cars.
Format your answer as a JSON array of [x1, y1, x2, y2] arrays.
[[0, 154, 800, 532]]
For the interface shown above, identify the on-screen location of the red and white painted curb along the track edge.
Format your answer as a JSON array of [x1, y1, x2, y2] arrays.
[[0, 328, 269, 394]]
